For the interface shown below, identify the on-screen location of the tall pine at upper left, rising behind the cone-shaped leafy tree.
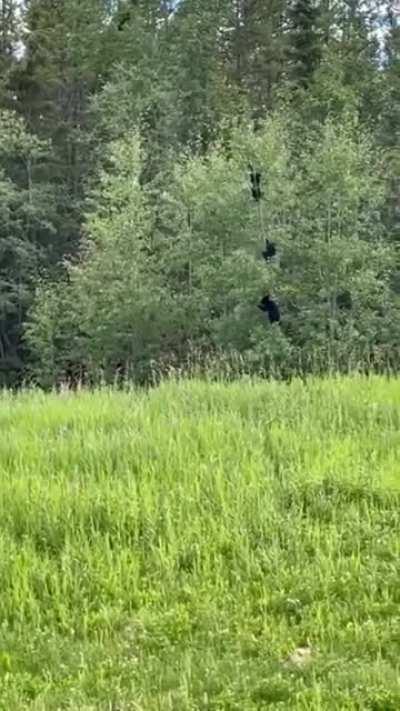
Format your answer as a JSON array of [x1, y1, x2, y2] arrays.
[[13, 0, 106, 259]]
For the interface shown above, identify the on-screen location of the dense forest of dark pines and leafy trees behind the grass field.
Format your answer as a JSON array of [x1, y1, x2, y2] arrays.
[[0, 0, 400, 386]]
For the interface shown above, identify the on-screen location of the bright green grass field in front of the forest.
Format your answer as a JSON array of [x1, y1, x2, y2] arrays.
[[0, 378, 400, 711]]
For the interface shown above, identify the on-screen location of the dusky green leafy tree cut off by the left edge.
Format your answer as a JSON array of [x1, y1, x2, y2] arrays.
[[0, 111, 52, 384]]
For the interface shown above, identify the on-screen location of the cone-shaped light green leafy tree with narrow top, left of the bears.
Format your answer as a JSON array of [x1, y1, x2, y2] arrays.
[[27, 129, 178, 379]]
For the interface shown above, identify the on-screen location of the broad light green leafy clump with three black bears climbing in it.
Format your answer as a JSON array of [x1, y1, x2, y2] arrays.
[[159, 110, 397, 372]]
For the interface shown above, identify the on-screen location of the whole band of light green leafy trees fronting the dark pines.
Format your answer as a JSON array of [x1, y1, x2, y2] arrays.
[[28, 109, 399, 384]]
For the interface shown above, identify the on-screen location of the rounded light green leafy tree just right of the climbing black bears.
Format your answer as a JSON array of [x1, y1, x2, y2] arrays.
[[272, 115, 398, 370]]
